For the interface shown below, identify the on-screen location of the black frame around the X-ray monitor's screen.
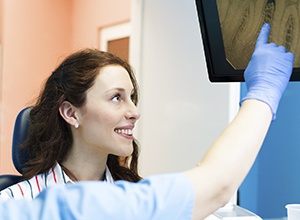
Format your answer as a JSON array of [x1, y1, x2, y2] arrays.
[[195, 0, 300, 82]]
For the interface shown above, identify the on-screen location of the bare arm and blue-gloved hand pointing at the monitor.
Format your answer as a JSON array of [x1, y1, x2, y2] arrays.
[[186, 24, 294, 219]]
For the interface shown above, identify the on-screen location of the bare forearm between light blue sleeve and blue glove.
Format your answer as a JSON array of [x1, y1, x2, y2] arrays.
[[187, 100, 272, 219]]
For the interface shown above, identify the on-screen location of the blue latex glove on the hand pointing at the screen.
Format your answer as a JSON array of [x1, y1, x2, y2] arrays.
[[241, 24, 294, 120]]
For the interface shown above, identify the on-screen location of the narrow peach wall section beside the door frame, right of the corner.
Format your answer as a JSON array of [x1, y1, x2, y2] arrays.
[[72, 0, 131, 50]]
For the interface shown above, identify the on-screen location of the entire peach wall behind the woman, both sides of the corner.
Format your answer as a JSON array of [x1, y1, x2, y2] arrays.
[[0, 0, 130, 174]]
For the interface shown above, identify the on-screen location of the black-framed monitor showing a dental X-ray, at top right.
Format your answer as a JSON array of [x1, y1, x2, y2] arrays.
[[196, 0, 300, 82]]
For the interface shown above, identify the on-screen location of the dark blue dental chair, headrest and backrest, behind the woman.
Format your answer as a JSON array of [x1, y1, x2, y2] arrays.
[[0, 107, 32, 191]]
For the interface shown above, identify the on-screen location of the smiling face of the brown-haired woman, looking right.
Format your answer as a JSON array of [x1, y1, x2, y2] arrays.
[[77, 65, 140, 156]]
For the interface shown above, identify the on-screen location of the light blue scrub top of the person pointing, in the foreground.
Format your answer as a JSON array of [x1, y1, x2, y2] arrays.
[[0, 173, 194, 220]]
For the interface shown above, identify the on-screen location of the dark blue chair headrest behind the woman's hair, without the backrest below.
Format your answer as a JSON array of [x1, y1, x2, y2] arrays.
[[12, 107, 32, 174]]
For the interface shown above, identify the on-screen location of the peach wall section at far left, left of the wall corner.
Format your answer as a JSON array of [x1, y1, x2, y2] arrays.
[[0, 0, 72, 173]]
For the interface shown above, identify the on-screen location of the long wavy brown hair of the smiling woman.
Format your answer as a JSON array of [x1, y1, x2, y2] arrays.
[[23, 49, 141, 182]]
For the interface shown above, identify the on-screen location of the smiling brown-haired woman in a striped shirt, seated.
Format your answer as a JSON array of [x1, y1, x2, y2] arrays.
[[1, 49, 141, 199]]
